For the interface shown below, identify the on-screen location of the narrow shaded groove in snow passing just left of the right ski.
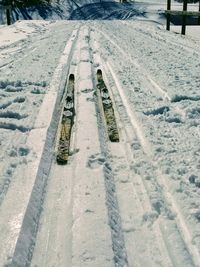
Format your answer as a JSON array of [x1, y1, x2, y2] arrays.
[[89, 33, 129, 267]]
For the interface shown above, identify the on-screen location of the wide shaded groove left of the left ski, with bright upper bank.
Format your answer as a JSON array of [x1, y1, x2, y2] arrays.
[[10, 27, 78, 267]]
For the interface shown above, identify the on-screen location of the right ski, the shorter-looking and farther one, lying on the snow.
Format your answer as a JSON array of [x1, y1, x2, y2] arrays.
[[97, 69, 119, 142]]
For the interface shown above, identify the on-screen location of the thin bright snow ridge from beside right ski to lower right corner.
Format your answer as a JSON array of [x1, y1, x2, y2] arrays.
[[103, 62, 200, 266]]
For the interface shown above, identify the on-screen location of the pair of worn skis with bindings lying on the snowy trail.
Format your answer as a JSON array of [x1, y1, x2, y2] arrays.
[[56, 69, 119, 164]]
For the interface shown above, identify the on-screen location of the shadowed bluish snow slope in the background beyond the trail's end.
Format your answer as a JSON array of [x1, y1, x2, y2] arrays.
[[0, 0, 172, 24]]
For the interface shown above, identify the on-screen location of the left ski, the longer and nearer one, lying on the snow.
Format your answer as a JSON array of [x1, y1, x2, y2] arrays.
[[56, 74, 75, 164]]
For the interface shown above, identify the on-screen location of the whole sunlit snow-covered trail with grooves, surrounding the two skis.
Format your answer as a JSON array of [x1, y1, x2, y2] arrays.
[[0, 21, 200, 267]]
